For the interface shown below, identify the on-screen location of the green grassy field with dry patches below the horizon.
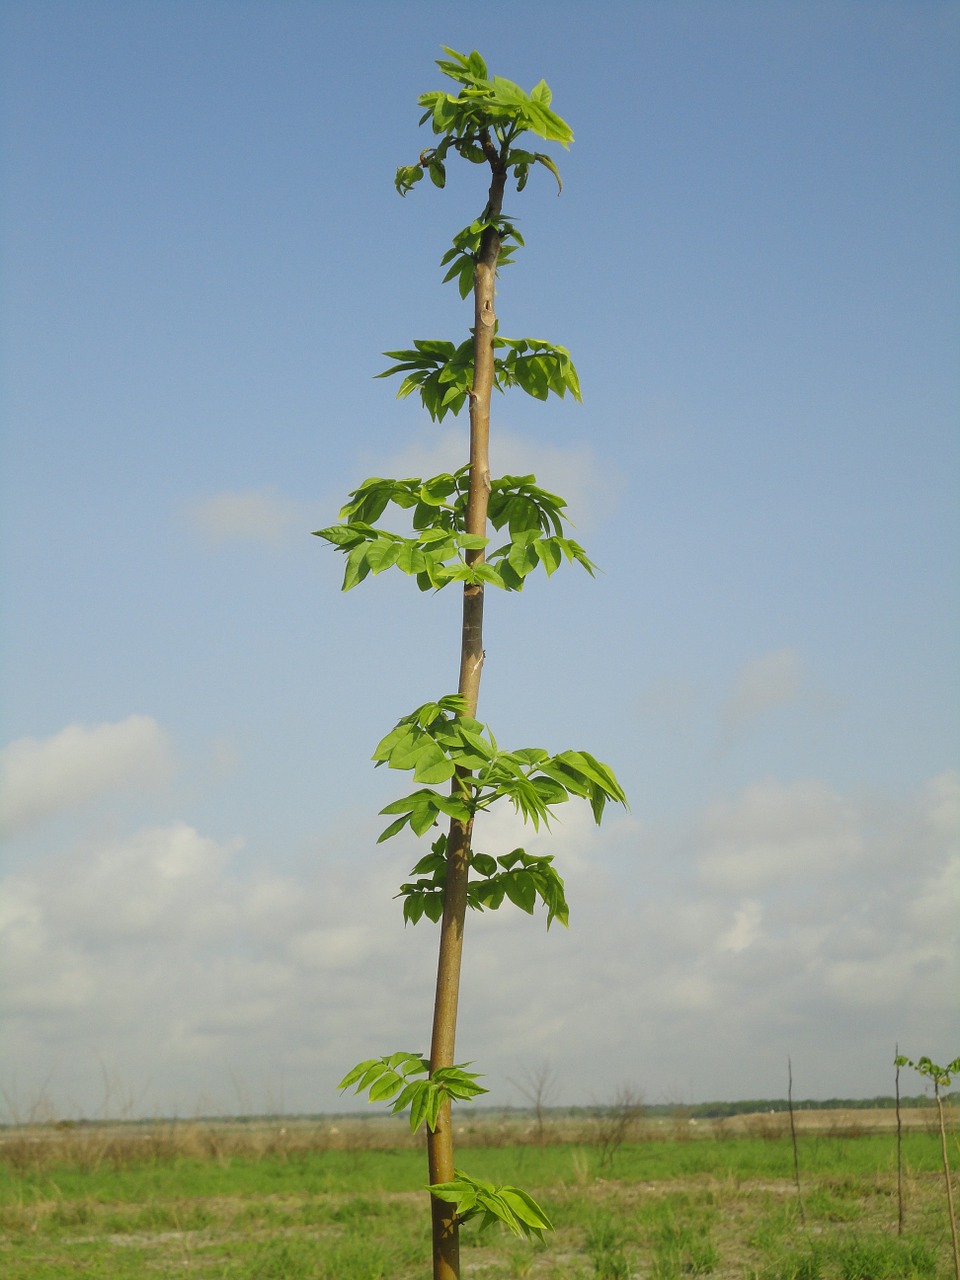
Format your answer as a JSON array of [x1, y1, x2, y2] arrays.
[[0, 1115, 952, 1280]]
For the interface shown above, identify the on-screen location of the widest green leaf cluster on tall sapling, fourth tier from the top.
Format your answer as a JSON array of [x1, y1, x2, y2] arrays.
[[315, 467, 596, 591]]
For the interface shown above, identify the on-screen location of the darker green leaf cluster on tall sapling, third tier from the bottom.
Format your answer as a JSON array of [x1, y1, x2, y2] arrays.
[[397, 835, 570, 929]]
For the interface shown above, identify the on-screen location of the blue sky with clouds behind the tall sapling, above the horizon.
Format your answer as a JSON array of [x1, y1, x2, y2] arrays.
[[0, 0, 960, 1116]]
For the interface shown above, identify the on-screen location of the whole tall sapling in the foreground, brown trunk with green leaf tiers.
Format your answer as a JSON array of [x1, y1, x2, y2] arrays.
[[317, 49, 626, 1280]]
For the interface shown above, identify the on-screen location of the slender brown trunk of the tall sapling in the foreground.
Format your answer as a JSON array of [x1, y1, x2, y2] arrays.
[[426, 142, 509, 1280]]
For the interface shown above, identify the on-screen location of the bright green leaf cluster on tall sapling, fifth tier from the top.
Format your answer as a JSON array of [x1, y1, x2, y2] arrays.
[[372, 695, 627, 844]]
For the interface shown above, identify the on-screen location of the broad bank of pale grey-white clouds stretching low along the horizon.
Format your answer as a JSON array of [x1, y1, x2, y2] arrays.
[[0, 774, 960, 1114]]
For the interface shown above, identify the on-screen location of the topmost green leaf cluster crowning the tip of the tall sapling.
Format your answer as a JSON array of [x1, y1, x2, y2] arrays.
[[394, 45, 573, 196]]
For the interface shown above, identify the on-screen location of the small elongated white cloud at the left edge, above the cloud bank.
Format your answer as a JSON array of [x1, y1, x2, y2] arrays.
[[0, 716, 173, 835]]
